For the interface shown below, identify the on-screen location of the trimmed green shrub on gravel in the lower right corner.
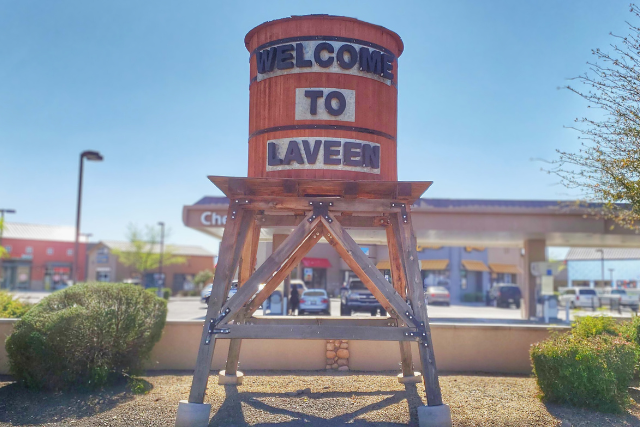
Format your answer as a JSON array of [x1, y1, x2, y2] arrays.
[[531, 334, 638, 412]]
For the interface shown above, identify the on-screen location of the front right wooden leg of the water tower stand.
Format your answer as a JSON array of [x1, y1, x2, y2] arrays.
[[391, 211, 442, 406]]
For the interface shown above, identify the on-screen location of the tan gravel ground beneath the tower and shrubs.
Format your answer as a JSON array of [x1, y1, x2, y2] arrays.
[[0, 372, 640, 427]]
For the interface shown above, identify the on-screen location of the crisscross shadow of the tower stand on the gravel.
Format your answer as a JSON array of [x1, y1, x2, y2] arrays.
[[209, 384, 424, 427]]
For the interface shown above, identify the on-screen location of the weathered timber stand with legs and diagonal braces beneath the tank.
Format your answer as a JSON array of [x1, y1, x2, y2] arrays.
[[189, 197, 442, 405]]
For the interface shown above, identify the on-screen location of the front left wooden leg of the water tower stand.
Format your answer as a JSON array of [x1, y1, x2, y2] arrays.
[[189, 204, 254, 403]]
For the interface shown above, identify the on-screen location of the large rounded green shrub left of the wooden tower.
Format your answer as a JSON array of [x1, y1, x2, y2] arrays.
[[6, 283, 167, 390]]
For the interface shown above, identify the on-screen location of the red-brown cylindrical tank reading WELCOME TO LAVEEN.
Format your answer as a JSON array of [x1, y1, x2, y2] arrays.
[[245, 15, 404, 181]]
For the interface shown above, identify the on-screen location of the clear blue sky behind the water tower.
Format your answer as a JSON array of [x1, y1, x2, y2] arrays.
[[0, 0, 632, 250]]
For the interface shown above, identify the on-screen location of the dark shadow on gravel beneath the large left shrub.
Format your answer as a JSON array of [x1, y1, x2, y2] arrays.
[[0, 377, 153, 425]]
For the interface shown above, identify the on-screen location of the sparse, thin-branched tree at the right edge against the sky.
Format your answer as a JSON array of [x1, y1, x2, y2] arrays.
[[549, 4, 640, 231]]
